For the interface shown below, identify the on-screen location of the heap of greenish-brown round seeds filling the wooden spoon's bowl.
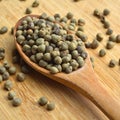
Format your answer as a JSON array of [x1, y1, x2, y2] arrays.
[[16, 14, 87, 73]]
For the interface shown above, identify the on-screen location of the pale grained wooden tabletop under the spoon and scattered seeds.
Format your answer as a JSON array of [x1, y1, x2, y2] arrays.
[[0, 0, 120, 120]]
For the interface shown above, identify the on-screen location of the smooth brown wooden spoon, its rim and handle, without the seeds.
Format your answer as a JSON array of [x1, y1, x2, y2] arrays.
[[14, 15, 120, 120]]
